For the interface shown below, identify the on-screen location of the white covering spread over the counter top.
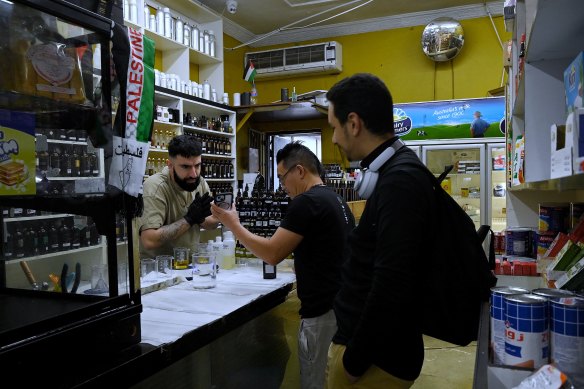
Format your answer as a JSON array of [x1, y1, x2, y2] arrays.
[[140, 267, 296, 346]]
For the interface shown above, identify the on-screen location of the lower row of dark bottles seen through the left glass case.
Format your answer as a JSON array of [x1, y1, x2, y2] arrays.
[[2, 216, 101, 260]]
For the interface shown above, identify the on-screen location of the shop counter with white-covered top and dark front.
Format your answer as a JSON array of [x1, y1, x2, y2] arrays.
[[36, 266, 297, 389]]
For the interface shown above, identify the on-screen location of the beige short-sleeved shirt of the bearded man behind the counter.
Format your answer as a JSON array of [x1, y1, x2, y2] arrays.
[[138, 166, 210, 258]]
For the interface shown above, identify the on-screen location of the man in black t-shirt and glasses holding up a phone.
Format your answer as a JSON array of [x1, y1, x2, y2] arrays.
[[211, 142, 355, 389]]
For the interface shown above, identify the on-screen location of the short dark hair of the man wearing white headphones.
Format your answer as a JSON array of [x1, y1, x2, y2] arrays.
[[326, 73, 394, 135]]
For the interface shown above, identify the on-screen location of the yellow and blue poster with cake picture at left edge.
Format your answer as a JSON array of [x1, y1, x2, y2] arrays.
[[0, 110, 36, 196]]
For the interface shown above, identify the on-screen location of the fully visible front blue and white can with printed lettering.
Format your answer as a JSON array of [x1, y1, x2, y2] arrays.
[[505, 294, 550, 369]]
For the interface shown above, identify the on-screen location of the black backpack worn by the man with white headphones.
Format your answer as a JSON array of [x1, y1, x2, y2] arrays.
[[395, 163, 497, 346]]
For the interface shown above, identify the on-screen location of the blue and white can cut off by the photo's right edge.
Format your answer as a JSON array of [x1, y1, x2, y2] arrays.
[[550, 296, 584, 388]]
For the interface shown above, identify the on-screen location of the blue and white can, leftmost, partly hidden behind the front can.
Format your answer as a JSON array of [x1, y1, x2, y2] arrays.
[[490, 286, 529, 365]]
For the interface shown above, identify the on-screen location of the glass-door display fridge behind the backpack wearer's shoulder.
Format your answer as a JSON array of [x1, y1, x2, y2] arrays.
[[406, 138, 506, 232]]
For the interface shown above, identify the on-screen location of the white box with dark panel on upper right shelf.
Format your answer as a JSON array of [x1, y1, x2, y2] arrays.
[[550, 123, 574, 178]]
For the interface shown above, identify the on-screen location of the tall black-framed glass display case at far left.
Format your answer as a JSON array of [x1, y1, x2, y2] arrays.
[[0, 0, 141, 387]]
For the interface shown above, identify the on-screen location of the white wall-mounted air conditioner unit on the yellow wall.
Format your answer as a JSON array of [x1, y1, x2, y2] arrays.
[[244, 41, 343, 79]]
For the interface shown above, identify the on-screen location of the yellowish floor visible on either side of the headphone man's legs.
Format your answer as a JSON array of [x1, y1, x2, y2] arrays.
[[276, 292, 476, 389]]
